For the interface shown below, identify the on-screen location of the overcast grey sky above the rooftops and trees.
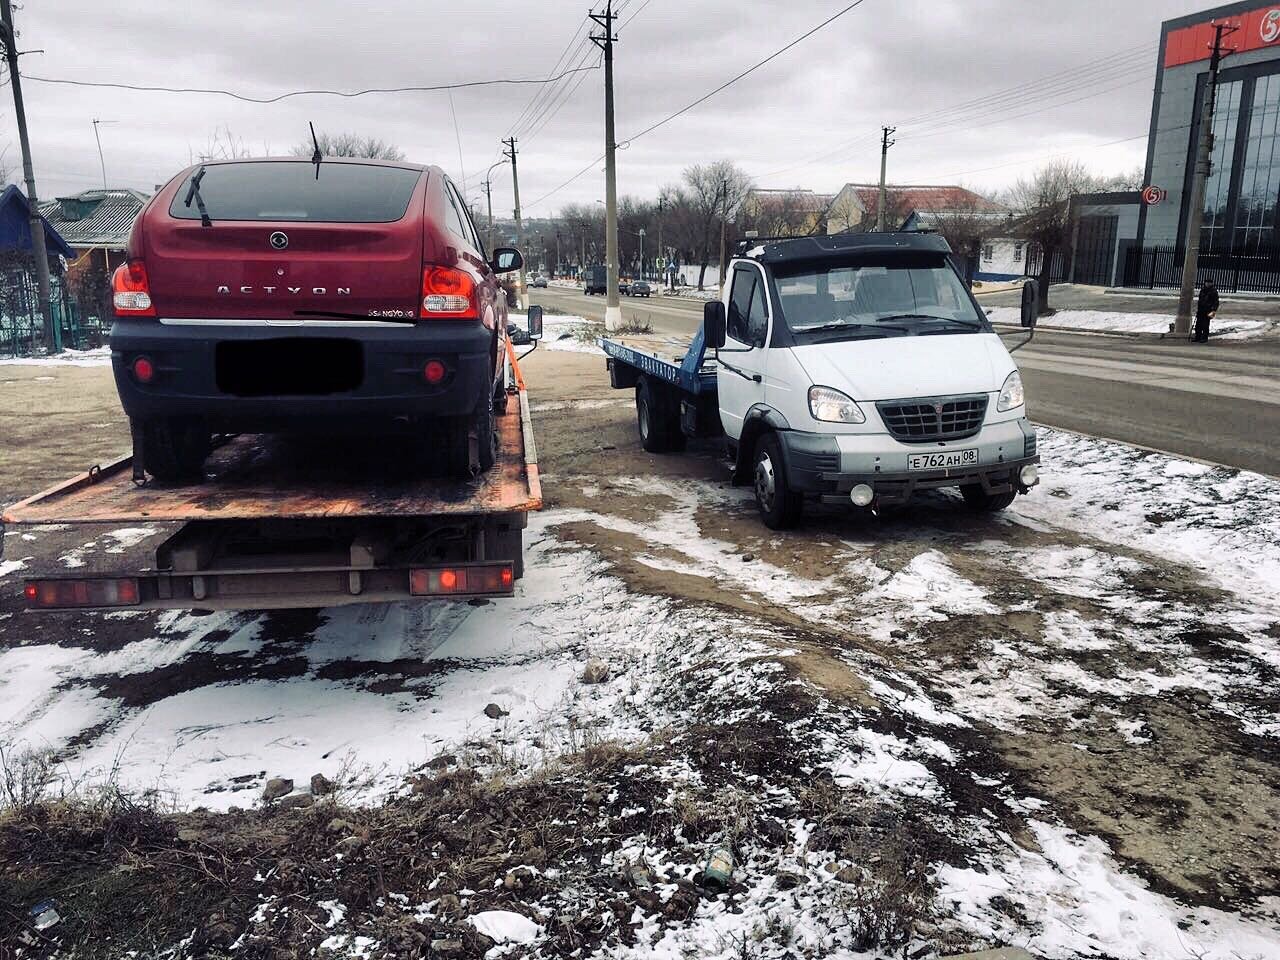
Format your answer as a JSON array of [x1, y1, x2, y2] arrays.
[[0, 0, 1206, 216]]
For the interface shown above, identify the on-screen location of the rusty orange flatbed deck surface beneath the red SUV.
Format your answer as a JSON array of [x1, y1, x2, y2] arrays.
[[3, 389, 543, 524]]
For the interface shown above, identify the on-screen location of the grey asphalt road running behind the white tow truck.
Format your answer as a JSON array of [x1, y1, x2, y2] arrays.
[[531, 288, 1280, 476]]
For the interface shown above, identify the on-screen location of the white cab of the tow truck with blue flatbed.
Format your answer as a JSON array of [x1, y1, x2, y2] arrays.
[[703, 233, 1039, 527]]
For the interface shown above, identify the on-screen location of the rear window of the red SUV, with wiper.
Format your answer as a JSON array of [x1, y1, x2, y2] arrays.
[[169, 161, 422, 223]]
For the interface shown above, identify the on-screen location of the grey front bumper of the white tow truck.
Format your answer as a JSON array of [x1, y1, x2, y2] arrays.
[[778, 417, 1041, 504]]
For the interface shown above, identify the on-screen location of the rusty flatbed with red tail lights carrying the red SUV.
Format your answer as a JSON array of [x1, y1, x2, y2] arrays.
[[0, 344, 543, 611]]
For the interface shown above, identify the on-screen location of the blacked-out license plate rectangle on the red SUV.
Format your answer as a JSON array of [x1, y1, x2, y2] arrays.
[[215, 337, 365, 397]]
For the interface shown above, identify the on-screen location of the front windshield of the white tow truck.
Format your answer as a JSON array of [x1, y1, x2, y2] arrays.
[[773, 257, 991, 343]]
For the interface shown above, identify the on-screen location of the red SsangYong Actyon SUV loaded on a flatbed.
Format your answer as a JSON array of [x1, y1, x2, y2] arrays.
[[111, 159, 521, 480]]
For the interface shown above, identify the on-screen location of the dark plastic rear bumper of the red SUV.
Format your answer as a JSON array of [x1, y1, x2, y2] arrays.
[[110, 319, 494, 433]]
